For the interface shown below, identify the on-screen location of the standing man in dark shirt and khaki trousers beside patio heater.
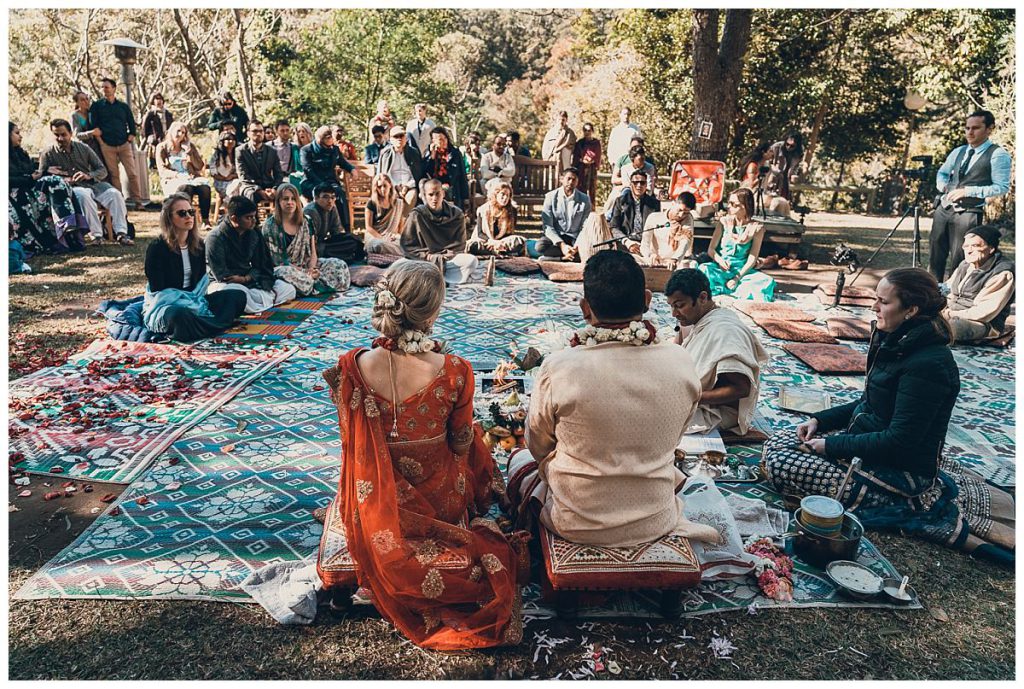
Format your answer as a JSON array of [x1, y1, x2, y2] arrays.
[[89, 78, 143, 210]]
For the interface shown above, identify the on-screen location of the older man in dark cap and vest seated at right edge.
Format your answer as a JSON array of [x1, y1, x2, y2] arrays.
[[943, 225, 1014, 342]]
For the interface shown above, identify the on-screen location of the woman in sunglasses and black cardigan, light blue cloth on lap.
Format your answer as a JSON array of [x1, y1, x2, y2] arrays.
[[142, 193, 246, 342]]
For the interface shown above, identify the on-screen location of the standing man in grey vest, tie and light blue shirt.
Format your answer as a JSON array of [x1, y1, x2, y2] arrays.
[[928, 111, 1013, 283]]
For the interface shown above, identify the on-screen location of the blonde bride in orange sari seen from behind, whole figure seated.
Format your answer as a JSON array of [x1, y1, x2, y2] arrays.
[[317, 260, 524, 650]]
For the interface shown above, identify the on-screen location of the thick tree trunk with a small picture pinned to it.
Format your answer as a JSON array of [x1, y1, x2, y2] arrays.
[[689, 9, 754, 161]]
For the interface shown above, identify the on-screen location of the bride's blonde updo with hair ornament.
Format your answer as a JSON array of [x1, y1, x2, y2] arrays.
[[370, 260, 444, 339]]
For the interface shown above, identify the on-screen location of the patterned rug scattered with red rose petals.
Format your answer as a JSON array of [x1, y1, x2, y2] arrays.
[[9, 340, 294, 483]]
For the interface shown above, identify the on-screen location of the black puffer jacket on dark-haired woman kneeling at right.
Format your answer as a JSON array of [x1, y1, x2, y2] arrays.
[[814, 319, 959, 478]]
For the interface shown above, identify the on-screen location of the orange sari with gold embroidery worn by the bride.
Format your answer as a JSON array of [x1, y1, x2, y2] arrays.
[[319, 348, 522, 650]]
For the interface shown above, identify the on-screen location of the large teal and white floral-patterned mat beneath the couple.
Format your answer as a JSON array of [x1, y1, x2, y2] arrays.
[[15, 274, 1014, 617]]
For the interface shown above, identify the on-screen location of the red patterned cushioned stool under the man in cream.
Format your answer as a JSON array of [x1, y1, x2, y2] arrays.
[[540, 525, 700, 591]]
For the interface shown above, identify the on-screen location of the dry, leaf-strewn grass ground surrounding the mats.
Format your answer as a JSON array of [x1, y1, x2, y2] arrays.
[[8, 207, 1016, 680]]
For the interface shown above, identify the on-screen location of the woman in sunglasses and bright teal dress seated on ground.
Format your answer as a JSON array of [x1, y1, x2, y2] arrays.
[[697, 188, 775, 301]]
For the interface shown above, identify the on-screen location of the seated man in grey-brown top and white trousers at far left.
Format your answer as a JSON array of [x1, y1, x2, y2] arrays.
[[38, 120, 135, 247]]
